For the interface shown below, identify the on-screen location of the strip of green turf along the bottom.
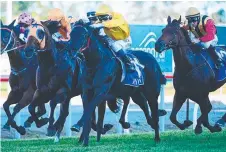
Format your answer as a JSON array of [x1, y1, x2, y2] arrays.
[[1, 130, 226, 152]]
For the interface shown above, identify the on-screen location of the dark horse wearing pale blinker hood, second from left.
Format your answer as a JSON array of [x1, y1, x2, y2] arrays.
[[25, 22, 74, 138]]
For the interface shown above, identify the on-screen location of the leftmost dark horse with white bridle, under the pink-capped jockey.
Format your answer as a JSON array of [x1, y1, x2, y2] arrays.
[[1, 20, 46, 135]]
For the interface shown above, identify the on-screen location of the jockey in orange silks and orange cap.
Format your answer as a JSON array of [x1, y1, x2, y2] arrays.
[[48, 8, 71, 43]]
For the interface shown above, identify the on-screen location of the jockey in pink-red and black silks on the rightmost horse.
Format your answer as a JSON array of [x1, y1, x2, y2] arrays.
[[184, 7, 223, 69]]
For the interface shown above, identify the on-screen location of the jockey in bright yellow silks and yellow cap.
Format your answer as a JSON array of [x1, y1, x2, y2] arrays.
[[87, 4, 132, 70]]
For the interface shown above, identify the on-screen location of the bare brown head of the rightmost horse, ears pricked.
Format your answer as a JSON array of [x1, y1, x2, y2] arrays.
[[155, 16, 185, 53]]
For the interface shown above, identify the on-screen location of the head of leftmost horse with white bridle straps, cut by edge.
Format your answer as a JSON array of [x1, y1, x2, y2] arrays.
[[0, 20, 16, 54]]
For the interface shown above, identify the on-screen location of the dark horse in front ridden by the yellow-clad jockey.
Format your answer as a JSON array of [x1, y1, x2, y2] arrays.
[[71, 22, 164, 146]]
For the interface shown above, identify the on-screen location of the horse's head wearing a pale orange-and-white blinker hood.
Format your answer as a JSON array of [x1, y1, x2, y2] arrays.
[[24, 22, 51, 58]]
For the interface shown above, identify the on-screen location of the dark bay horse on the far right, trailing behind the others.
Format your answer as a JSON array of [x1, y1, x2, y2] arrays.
[[155, 17, 226, 134]]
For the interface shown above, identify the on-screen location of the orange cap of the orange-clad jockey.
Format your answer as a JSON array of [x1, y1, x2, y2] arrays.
[[48, 8, 65, 21]]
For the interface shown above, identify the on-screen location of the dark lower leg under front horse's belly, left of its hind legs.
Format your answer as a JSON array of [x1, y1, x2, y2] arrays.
[[119, 97, 130, 129]]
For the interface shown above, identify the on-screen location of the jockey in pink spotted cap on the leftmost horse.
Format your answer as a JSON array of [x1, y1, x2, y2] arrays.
[[16, 12, 35, 42]]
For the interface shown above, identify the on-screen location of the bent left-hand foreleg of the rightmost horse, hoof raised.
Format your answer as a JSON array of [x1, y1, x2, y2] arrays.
[[170, 91, 187, 130]]
